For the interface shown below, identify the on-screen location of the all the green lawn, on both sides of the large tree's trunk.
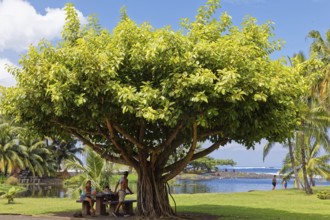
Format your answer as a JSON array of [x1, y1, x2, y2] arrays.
[[0, 187, 330, 220]]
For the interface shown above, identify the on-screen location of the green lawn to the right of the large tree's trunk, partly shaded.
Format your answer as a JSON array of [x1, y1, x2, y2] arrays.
[[175, 187, 330, 220]]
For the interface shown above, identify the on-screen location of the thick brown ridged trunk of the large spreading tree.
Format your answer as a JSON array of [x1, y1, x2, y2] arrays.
[[137, 164, 174, 219]]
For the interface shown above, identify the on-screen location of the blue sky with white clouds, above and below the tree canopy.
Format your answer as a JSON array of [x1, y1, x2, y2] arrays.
[[0, 0, 330, 166]]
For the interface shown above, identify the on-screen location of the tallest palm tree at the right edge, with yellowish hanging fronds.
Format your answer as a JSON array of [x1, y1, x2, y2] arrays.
[[293, 45, 330, 194]]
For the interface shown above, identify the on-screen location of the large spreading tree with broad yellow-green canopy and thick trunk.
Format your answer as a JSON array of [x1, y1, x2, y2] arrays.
[[2, 0, 304, 218]]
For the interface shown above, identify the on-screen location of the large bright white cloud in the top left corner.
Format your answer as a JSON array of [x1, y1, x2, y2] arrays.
[[0, 0, 87, 52]]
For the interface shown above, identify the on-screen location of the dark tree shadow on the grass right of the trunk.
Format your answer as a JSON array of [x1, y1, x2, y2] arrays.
[[177, 204, 330, 220]]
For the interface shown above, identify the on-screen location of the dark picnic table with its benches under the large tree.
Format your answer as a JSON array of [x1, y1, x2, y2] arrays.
[[76, 193, 136, 215]]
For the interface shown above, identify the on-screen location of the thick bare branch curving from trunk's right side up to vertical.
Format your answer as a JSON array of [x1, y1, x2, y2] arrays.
[[162, 122, 197, 183]]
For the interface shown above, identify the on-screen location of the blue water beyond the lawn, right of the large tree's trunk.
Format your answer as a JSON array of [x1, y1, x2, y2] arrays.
[[171, 167, 330, 194]]
